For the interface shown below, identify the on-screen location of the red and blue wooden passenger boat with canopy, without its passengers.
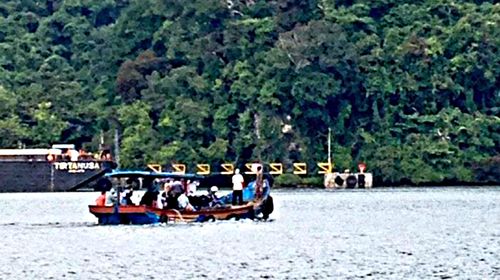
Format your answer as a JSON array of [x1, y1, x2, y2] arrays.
[[88, 171, 274, 225]]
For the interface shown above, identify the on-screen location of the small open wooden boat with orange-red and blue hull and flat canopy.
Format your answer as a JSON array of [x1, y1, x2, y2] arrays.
[[89, 171, 273, 224]]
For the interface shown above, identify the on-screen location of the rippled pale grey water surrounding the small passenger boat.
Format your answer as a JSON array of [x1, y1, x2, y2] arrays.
[[0, 187, 500, 279]]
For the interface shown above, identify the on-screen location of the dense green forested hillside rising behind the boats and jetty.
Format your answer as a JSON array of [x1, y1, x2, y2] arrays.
[[0, 0, 500, 183]]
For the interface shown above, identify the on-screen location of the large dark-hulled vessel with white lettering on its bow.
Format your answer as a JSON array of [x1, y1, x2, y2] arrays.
[[0, 144, 116, 192]]
